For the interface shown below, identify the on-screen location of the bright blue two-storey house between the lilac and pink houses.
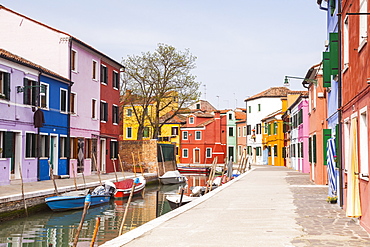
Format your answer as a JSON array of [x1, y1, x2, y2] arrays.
[[38, 74, 70, 180]]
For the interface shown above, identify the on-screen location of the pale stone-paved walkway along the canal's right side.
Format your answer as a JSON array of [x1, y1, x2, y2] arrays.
[[102, 166, 370, 247]]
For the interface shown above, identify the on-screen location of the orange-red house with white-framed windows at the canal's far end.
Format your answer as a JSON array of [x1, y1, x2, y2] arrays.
[[180, 111, 226, 164]]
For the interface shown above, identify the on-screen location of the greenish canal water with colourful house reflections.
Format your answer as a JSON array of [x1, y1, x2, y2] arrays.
[[0, 176, 206, 247]]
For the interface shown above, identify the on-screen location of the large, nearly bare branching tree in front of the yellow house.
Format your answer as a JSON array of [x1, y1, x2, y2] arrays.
[[123, 44, 200, 139]]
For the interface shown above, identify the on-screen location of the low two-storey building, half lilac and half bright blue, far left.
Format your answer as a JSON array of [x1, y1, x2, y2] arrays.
[[0, 49, 70, 185]]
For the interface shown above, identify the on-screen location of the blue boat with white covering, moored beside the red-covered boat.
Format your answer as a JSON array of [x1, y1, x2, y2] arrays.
[[45, 181, 116, 211]]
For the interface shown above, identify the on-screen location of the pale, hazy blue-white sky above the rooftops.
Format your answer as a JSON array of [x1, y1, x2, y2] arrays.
[[0, 0, 327, 109]]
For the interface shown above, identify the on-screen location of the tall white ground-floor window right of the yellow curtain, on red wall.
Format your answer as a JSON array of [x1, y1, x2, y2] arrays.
[[359, 108, 369, 177]]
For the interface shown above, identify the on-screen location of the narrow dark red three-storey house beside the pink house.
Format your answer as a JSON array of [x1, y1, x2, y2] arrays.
[[98, 58, 122, 172]]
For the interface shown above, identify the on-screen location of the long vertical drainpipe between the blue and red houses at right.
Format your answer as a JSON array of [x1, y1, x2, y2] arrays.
[[337, 0, 343, 208]]
